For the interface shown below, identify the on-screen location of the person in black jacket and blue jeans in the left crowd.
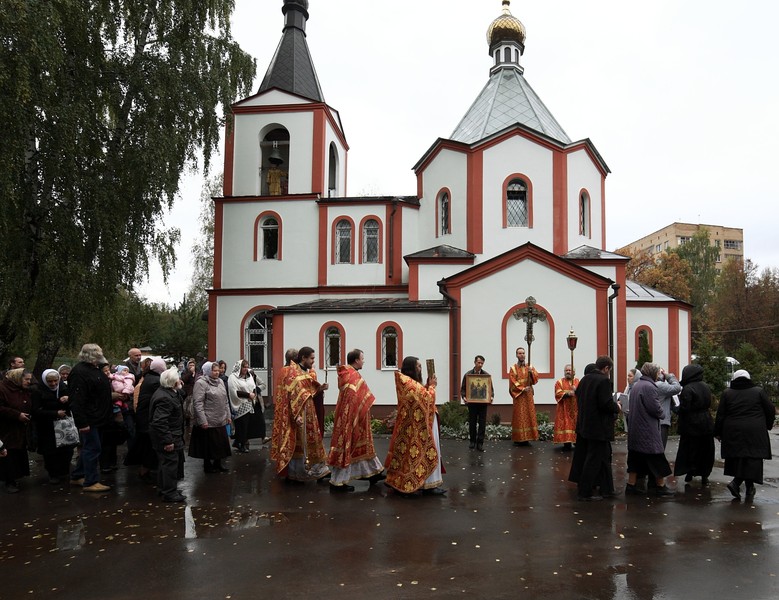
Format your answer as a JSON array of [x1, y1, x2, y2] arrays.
[[68, 344, 112, 492]]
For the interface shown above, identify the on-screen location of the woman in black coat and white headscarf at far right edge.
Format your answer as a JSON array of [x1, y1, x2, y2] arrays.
[[714, 369, 776, 500]]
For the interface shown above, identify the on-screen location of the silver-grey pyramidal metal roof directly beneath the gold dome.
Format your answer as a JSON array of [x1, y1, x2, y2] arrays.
[[451, 67, 571, 144]]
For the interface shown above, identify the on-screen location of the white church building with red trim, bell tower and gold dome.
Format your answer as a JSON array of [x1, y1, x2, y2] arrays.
[[209, 0, 691, 416]]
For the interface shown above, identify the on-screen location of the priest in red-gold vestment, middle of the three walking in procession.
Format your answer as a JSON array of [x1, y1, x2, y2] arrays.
[[327, 350, 384, 492]]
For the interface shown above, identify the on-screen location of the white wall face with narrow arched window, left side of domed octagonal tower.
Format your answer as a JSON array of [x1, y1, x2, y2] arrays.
[[420, 149, 468, 252]]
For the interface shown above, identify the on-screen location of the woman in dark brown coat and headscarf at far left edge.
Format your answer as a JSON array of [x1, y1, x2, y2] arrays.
[[0, 368, 32, 494]]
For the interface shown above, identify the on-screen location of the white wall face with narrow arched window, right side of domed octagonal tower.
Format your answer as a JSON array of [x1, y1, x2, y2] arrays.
[[568, 150, 605, 250]]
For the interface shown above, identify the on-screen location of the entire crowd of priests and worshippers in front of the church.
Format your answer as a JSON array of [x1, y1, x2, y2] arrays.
[[0, 344, 775, 502]]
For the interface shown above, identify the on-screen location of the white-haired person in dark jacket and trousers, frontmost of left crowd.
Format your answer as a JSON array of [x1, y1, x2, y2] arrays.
[[149, 367, 186, 502]]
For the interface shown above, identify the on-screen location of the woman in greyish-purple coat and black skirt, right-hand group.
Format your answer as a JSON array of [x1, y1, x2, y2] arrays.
[[625, 363, 674, 496]]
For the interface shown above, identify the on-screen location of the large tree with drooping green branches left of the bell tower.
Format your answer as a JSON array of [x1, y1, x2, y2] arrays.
[[0, 0, 256, 368]]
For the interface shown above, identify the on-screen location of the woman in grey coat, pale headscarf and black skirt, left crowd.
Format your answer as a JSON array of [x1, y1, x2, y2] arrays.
[[189, 362, 232, 473]]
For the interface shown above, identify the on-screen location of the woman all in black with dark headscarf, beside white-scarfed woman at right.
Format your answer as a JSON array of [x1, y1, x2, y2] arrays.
[[674, 365, 714, 485]]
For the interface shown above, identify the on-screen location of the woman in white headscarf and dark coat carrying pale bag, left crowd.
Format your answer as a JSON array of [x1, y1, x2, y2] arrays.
[[32, 369, 74, 484]]
